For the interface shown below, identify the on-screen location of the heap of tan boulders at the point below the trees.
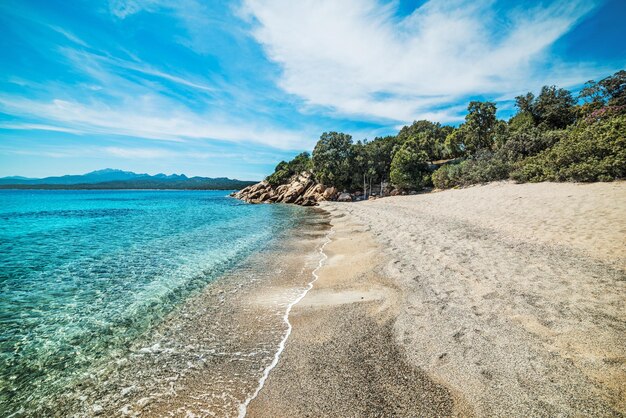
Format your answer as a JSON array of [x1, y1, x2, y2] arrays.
[[231, 171, 339, 206]]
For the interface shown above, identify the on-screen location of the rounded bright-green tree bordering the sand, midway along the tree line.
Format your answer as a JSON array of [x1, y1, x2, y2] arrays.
[[390, 140, 428, 190]]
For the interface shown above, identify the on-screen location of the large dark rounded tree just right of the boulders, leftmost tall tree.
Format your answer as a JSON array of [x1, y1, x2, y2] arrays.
[[312, 132, 352, 189]]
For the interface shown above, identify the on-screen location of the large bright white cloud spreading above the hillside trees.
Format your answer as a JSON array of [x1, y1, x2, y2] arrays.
[[242, 0, 597, 121]]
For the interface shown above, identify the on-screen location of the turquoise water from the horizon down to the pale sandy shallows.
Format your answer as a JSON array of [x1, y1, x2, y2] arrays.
[[0, 190, 304, 416]]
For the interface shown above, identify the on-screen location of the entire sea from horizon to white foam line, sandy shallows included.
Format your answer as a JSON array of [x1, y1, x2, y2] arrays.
[[0, 190, 328, 417]]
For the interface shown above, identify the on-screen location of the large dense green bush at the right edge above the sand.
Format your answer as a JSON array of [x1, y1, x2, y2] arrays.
[[511, 115, 626, 182]]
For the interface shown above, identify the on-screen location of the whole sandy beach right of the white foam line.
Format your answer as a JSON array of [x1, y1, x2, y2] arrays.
[[248, 182, 626, 417]]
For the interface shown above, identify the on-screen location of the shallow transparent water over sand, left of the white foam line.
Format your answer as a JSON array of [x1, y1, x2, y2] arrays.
[[38, 209, 330, 416]]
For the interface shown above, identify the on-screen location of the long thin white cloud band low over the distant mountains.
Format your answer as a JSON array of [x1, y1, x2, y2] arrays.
[[0, 95, 310, 149]]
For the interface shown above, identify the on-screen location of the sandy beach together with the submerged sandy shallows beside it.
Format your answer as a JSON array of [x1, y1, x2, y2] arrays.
[[14, 182, 626, 417]]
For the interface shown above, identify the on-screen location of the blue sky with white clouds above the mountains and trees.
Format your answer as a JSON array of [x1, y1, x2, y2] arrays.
[[0, 0, 626, 180]]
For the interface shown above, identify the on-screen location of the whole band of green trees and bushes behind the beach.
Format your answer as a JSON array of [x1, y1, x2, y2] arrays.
[[266, 70, 626, 194]]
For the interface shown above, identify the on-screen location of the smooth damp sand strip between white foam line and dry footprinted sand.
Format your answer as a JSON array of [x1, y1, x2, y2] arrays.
[[247, 207, 463, 417]]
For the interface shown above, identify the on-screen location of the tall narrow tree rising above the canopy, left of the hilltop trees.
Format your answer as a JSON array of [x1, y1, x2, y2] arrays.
[[460, 101, 497, 155]]
